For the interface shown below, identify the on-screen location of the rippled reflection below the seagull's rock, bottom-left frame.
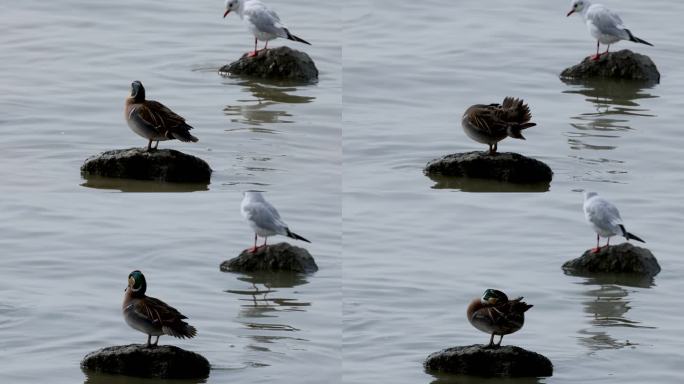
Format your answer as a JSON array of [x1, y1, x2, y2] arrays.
[[226, 272, 311, 352]]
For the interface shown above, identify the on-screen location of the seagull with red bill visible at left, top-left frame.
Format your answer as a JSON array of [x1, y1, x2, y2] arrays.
[[223, 0, 311, 57]]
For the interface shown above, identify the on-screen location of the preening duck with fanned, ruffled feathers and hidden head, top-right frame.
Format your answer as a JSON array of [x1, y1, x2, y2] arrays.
[[461, 97, 537, 154]]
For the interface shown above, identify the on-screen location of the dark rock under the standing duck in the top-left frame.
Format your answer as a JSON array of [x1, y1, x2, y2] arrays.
[[81, 148, 211, 183]]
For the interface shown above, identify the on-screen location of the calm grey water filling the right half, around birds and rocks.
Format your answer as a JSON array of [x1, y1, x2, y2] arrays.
[[343, 0, 684, 383]]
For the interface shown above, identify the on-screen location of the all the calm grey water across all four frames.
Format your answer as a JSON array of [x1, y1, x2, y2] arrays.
[[0, 0, 684, 384]]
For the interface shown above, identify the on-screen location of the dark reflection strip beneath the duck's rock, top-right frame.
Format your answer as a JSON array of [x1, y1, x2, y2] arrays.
[[428, 175, 550, 192]]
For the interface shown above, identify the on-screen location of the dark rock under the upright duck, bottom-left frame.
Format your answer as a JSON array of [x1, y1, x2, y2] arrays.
[[81, 344, 211, 379]]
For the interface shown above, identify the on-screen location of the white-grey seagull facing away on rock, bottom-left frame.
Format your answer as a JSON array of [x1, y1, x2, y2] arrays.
[[240, 191, 310, 253]]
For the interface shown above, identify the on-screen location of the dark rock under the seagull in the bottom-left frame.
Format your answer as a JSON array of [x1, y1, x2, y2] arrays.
[[221, 243, 318, 273]]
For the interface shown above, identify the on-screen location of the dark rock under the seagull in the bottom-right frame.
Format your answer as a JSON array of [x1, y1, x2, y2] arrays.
[[563, 243, 660, 276]]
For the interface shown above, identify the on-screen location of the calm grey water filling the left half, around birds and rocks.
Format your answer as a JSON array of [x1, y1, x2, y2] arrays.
[[0, 0, 342, 383]]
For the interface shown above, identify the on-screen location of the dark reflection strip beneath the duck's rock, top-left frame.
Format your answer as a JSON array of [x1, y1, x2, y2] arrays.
[[81, 176, 209, 192]]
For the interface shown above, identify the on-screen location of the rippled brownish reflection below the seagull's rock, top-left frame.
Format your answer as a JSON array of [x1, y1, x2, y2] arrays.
[[223, 80, 315, 127]]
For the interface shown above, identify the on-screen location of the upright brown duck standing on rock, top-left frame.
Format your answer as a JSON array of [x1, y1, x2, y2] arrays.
[[124, 80, 198, 151]]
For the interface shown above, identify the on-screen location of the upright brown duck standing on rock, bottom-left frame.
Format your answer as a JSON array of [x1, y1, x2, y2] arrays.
[[122, 270, 197, 347]]
